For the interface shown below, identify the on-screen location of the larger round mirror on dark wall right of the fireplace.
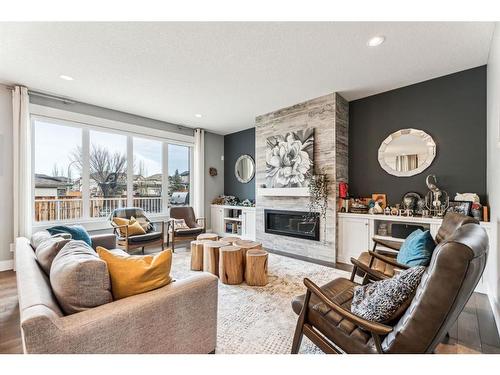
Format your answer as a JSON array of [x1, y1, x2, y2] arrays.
[[378, 129, 436, 177]]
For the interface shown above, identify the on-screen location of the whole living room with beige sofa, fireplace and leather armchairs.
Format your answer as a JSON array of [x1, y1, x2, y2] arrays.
[[0, 1, 500, 372]]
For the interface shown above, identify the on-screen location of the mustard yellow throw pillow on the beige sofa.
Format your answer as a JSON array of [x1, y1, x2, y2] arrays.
[[97, 246, 172, 299]]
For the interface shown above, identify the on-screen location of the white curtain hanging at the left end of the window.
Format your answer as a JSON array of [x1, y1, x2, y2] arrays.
[[12, 86, 32, 238]]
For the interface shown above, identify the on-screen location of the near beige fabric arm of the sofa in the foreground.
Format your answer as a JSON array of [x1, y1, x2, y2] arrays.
[[22, 273, 218, 354]]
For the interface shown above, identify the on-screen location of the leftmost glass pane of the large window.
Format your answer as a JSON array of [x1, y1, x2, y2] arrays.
[[33, 121, 83, 221]]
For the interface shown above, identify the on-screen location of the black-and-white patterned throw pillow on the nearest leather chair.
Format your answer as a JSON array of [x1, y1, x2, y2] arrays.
[[351, 266, 425, 323]]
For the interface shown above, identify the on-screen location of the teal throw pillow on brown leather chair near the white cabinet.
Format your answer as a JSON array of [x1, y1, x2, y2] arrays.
[[397, 229, 436, 267]]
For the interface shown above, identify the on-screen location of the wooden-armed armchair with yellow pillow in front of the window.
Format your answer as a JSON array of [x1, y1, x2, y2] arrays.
[[110, 207, 165, 253]]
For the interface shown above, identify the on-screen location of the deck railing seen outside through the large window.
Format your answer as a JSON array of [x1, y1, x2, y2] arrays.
[[35, 197, 163, 221]]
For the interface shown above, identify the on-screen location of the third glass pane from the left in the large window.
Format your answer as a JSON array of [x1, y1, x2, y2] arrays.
[[133, 137, 163, 213]]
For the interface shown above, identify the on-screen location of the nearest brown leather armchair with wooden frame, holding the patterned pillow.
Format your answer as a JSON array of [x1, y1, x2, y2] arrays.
[[292, 220, 488, 354]]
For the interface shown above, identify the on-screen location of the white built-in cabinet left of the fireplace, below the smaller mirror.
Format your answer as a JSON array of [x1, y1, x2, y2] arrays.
[[210, 204, 255, 240]]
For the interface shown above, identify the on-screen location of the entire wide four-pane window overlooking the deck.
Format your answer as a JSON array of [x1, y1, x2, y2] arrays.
[[32, 115, 193, 222]]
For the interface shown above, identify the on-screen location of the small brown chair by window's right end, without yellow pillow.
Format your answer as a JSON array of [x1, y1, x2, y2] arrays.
[[167, 207, 205, 251]]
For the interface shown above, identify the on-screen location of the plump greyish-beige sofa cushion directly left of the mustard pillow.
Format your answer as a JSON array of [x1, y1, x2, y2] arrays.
[[50, 241, 113, 314]]
